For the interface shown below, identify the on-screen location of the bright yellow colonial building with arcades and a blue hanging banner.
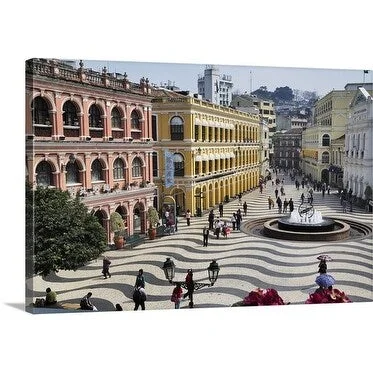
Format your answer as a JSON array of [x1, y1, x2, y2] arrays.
[[152, 90, 261, 216]]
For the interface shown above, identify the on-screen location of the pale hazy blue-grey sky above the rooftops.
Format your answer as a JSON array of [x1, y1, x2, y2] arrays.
[[80, 60, 373, 97]]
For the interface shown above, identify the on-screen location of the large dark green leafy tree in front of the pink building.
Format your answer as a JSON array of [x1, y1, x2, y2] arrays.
[[26, 187, 106, 276]]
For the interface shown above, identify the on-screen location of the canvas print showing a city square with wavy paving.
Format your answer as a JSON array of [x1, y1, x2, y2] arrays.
[[25, 58, 373, 314]]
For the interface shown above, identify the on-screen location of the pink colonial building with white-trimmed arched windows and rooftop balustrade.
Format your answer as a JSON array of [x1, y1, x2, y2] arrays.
[[26, 59, 156, 243]]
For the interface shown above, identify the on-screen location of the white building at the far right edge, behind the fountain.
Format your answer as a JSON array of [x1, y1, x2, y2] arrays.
[[343, 87, 373, 202]]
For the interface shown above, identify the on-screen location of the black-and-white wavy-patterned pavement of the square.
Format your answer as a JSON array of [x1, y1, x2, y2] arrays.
[[27, 177, 373, 311]]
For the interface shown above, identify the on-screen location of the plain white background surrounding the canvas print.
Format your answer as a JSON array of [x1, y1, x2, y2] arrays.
[[0, 0, 373, 372]]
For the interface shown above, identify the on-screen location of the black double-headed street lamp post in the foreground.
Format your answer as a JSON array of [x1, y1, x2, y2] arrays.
[[162, 258, 220, 308]]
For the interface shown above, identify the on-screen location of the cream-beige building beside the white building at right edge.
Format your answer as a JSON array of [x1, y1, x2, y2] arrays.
[[302, 83, 372, 184]]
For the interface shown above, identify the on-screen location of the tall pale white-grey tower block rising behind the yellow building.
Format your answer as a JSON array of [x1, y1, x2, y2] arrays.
[[198, 65, 233, 106]]
